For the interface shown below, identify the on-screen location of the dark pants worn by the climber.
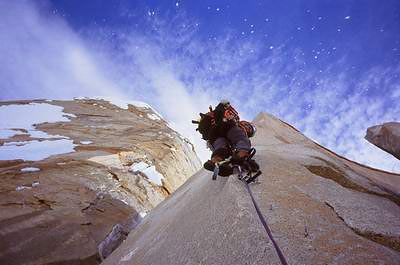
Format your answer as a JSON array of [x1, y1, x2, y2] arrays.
[[212, 126, 251, 157]]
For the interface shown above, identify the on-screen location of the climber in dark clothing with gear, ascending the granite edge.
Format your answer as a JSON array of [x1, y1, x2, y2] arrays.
[[192, 100, 259, 176]]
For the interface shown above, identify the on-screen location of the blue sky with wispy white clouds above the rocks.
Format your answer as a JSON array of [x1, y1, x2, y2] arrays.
[[0, 0, 400, 171]]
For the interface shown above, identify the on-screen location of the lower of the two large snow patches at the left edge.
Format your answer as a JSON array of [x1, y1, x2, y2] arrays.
[[0, 139, 76, 161]]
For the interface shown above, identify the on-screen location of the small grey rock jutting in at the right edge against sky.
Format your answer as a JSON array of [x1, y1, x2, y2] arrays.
[[365, 122, 400, 159]]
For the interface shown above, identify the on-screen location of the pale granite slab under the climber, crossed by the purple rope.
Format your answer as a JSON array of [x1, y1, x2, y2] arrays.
[[102, 113, 400, 265]]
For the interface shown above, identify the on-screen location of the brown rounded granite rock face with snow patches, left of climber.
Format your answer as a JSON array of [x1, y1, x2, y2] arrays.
[[0, 99, 201, 265]]
